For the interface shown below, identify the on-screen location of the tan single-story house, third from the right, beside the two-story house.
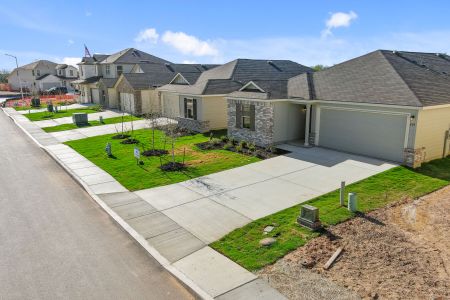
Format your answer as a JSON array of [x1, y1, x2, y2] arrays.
[[113, 63, 217, 114]]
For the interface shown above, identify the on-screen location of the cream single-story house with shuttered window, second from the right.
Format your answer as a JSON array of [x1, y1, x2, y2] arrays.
[[158, 59, 311, 132]]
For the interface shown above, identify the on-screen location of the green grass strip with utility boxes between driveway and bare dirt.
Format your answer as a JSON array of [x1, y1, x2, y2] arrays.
[[211, 157, 450, 271]]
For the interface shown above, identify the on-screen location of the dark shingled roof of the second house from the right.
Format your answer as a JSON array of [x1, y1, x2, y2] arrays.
[[162, 59, 312, 95]]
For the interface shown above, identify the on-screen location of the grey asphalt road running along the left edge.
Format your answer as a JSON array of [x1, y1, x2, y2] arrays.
[[0, 112, 192, 299]]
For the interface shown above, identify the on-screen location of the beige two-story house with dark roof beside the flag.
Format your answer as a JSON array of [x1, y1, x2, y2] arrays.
[[76, 48, 170, 107]]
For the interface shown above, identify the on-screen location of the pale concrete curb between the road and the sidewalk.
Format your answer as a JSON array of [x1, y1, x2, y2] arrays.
[[2, 108, 213, 300]]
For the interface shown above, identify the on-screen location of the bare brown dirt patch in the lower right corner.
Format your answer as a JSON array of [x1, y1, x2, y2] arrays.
[[259, 186, 450, 299]]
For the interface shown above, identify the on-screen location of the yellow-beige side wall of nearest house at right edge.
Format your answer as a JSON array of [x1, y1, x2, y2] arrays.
[[415, 107, 450, 161]]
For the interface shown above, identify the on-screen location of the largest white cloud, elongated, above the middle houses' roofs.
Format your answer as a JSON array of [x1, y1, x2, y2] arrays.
[[162, 31, 219, 56]]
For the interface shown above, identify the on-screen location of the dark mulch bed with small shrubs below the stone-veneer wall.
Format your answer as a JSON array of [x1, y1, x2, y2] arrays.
[[196, 136, 289, 159]]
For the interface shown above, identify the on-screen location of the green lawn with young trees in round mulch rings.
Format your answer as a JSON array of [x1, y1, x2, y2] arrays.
[[66, 129, 259, 191]]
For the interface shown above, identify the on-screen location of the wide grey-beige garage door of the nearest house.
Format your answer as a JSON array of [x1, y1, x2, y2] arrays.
[[319, 108, 407, 162]]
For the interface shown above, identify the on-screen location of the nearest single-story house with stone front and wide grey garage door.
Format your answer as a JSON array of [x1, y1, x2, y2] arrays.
[[227, 50, 450, 167]]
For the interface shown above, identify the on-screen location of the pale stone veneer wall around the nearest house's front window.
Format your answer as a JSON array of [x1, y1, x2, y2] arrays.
[[227, 100, 274, 146]]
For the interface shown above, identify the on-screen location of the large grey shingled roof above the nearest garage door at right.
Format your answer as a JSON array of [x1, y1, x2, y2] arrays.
[[288, 50, 450, 107]]
